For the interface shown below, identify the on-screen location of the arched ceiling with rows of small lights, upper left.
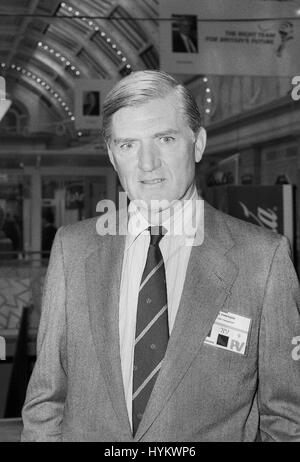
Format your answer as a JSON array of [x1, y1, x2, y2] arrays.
[[0, 0, 159, 137]]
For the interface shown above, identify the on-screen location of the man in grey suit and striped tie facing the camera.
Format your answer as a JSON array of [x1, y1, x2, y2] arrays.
[[22, 71, 300, 442]]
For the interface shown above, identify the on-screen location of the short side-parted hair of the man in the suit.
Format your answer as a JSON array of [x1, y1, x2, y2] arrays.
[[102, 70, 202, 142]]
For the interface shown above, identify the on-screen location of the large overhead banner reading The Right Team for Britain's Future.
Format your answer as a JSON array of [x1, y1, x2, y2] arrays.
[[159, 0, 300, 77]]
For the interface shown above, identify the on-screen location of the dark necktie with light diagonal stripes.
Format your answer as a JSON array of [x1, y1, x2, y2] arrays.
[[132, 226, 169, 434]]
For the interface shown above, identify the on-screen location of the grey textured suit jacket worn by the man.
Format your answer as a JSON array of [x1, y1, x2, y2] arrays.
[[22, 204, 300, 442]]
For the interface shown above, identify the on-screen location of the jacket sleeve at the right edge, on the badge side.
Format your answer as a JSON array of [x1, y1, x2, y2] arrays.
[[258, 237, 300, 441]]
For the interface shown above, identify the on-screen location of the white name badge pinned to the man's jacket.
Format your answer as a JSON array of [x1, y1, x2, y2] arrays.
[[204, 311, 251, 355]]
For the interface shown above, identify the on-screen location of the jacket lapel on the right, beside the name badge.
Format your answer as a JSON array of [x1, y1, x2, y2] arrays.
[[135, 205, 237, 441]]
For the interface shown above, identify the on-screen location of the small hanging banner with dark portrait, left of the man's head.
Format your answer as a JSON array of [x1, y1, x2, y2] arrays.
[[75, 79, 113, 130]]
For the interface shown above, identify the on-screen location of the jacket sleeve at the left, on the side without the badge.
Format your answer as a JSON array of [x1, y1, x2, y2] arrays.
[[21, 229, 67, 441]]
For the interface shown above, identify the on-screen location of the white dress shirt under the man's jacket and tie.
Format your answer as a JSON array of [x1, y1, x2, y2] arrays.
[[119, 188, 203, 425]]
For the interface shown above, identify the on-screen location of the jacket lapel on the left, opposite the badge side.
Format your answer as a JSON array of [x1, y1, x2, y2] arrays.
[[86, 224, 132, 439]]
